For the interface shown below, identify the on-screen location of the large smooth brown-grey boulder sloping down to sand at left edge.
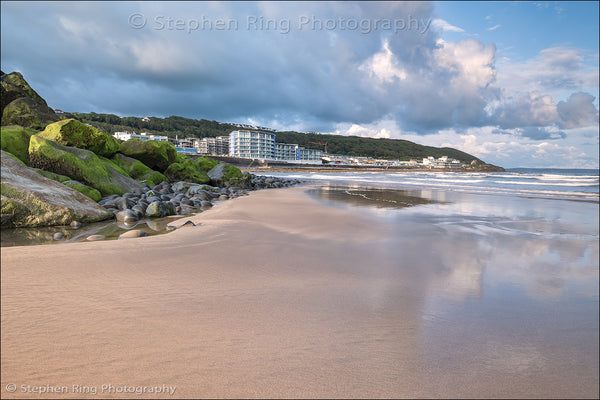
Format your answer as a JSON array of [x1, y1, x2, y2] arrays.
[[0, 151, 112, 228]]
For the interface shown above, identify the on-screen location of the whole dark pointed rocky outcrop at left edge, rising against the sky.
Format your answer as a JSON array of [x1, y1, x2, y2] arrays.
[[0, 72, 60, 129]]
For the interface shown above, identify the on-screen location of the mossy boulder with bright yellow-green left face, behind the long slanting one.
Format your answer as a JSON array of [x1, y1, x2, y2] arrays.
[[39, 119, 119, 157]]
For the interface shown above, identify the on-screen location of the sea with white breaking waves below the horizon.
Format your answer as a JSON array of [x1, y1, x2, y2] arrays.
[[258, 168, 600, 202]]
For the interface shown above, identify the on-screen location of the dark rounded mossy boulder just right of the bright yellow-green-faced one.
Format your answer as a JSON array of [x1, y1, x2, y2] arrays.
[[119, 139, 178, 173]]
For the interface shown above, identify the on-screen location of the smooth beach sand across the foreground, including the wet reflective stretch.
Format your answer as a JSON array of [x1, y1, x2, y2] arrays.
[[1, 187, 599, 398]]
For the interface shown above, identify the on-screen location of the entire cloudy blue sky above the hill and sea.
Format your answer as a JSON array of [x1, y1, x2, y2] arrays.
[[0, 1, 599, 168]]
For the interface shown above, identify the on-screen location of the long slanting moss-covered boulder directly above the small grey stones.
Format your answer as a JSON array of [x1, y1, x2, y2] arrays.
[[29, 135, 144, 196]]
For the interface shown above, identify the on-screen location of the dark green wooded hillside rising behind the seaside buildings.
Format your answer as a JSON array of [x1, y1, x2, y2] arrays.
[[73, 113, 492, 164]]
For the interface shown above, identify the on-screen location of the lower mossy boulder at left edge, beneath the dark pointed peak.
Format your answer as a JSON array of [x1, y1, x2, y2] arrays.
[[2, 97, 59, 129]]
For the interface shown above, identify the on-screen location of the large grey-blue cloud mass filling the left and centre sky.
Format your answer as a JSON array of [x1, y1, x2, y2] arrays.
[[2, 2, 597, 139]]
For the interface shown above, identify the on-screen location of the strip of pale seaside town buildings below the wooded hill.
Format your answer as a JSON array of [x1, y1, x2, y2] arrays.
[[113, 126, 467, 169]]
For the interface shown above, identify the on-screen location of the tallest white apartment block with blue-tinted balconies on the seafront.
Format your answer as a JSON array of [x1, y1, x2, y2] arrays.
[[229, 131, 275, 160]]
